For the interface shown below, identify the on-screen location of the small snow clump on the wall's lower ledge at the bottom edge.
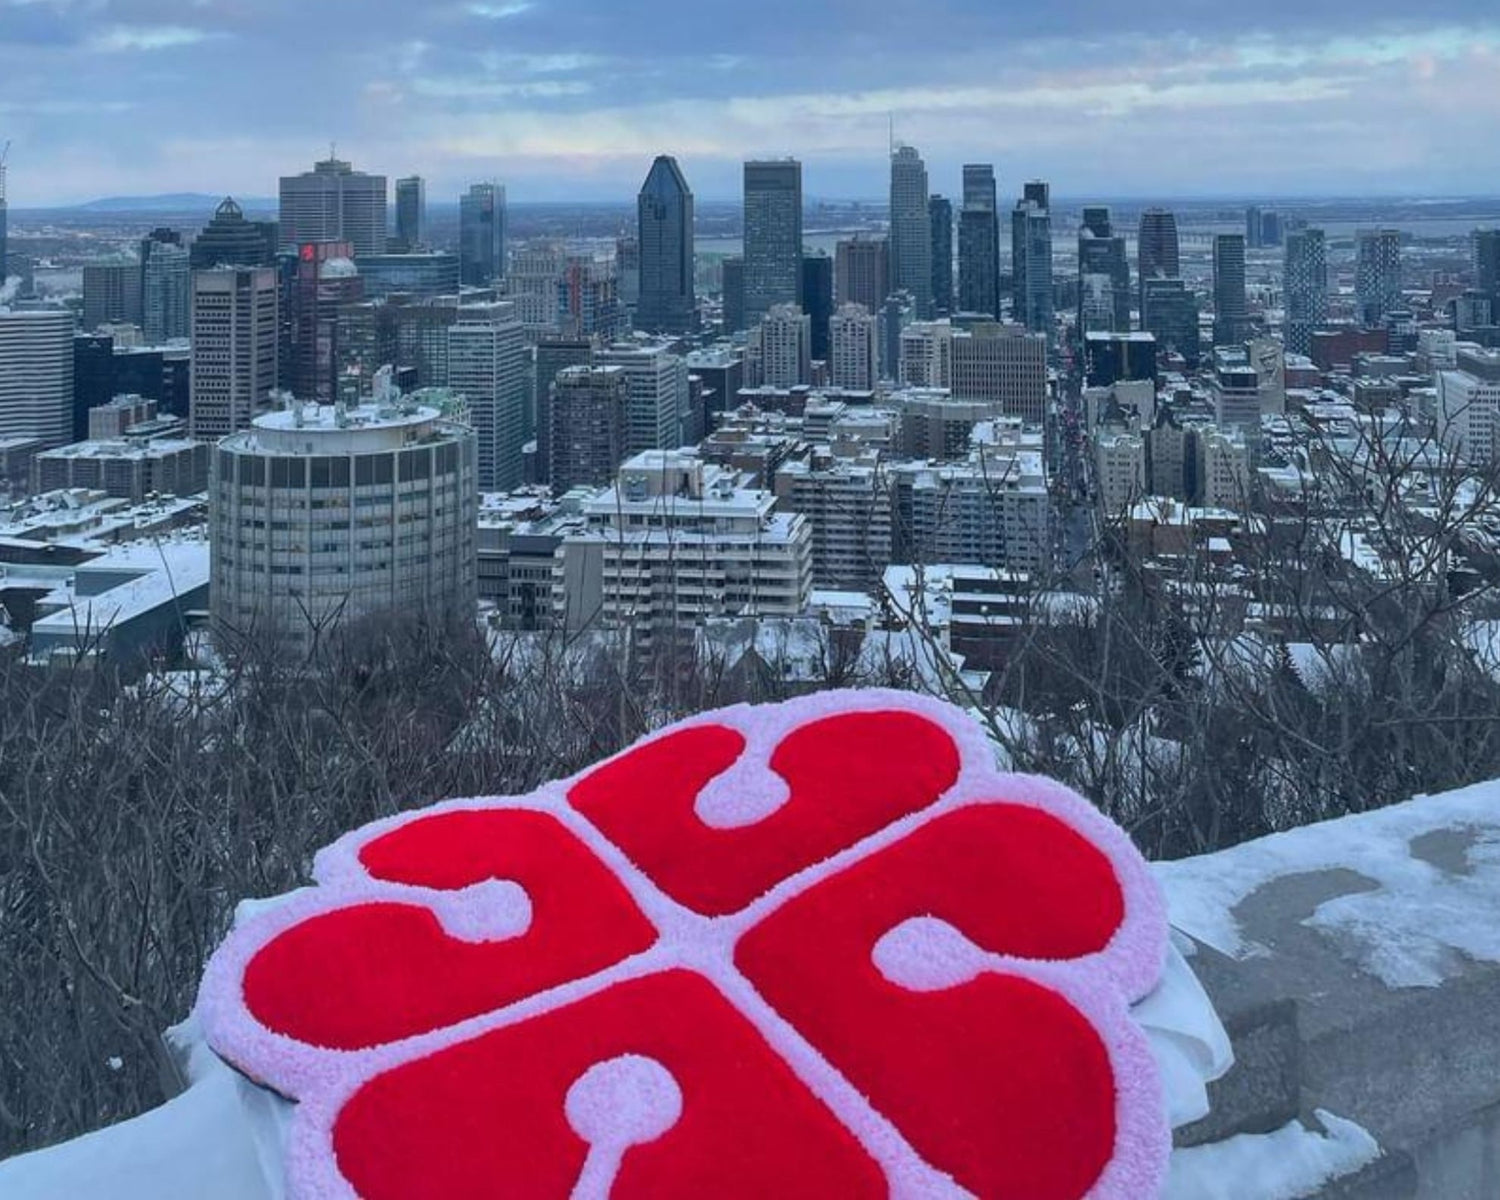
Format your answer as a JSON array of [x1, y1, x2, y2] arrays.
[[1164, 1109, 1380, 1200]]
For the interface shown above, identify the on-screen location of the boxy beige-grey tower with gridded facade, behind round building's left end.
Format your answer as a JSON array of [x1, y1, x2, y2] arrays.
[[188, 267, 279, 438]]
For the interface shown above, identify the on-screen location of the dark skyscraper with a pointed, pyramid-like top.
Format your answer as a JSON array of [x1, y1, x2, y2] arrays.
[[639, 155, 698, 334]]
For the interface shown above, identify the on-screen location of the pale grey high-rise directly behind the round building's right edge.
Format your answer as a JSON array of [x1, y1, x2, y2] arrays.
[[449, 302, 530, 492]]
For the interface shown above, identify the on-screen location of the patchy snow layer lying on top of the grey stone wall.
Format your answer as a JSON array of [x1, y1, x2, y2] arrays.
[[1155, 783, 1500, 989]]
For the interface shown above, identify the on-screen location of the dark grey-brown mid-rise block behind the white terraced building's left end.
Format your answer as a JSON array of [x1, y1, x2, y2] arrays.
[[548, 366, 630, 494]]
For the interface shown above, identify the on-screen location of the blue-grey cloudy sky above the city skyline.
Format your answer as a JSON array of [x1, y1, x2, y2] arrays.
[[0, 0, 1500, 207]]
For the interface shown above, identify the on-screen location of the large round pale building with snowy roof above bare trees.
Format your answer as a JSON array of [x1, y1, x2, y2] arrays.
[[209, 398, 479, 653]]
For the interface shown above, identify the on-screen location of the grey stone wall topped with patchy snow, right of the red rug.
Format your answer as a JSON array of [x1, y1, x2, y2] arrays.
[[1157, 783, 1500, 1200]]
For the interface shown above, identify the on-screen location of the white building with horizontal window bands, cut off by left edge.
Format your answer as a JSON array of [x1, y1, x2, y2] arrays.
[[0, 309, 74, 447]]
